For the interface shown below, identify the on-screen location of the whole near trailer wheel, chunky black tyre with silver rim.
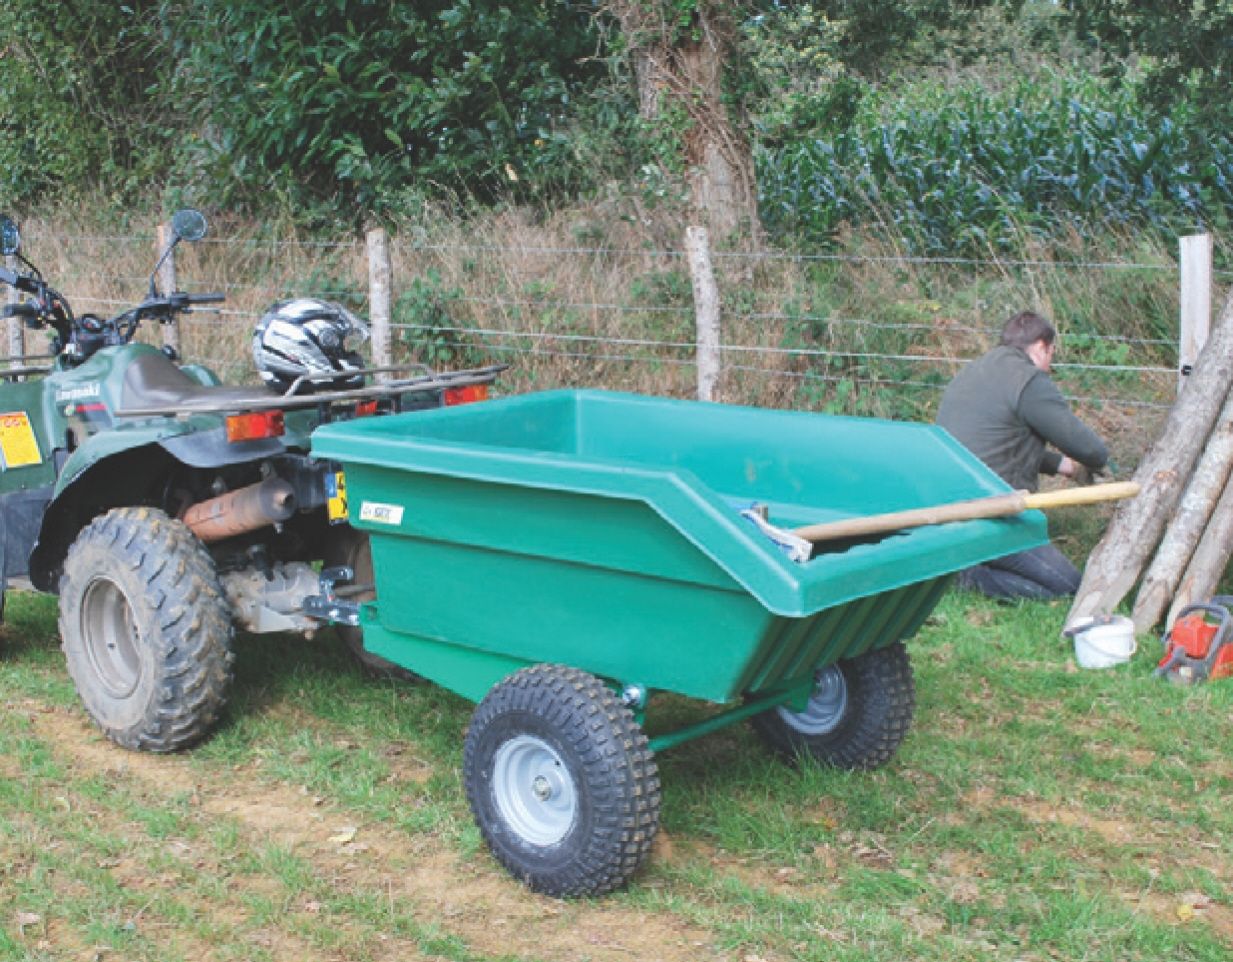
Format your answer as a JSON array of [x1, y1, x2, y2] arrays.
[[462, 665, 660, 898]]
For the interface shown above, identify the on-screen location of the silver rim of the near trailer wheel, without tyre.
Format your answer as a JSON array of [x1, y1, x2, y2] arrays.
[[492, 735, 578, 845]]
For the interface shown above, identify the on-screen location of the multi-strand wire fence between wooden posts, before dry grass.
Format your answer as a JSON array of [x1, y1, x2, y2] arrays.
[[10, 224, 1198, 429]]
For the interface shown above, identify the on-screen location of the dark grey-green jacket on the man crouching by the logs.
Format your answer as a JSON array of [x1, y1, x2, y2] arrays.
[[937, 345, 1108, 491]]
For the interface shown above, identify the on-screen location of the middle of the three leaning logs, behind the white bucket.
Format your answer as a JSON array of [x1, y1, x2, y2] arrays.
[[1133, 395, 1233, 633]]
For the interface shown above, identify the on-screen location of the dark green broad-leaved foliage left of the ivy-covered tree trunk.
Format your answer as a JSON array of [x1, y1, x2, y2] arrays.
[[166, 0, 616, 210]]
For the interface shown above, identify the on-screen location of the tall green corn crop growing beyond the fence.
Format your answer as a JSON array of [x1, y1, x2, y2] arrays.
[[758, 74, 1233, 254]]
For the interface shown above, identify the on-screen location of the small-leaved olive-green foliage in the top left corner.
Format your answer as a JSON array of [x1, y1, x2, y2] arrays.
[[0, 0, 176, 204]]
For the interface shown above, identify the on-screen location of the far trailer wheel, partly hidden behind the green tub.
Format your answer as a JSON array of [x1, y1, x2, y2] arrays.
[[752, 641, 916, 768]]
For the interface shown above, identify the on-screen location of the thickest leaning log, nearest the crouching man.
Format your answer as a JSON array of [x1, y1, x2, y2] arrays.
[[1067, 291, 1233, 625]]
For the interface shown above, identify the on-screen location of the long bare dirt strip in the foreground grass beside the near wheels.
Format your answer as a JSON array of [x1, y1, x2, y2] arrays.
[[33, 712, 741, 962]]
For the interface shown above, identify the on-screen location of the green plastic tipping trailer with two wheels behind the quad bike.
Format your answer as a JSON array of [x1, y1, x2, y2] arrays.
[[312, 391, 1046, 897]]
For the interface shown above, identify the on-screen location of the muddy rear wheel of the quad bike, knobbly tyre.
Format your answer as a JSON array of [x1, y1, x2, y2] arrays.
[[59, 508, 233, 751]]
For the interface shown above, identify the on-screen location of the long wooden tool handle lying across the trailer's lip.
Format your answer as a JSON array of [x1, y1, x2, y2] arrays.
[[793, 481, 1139, 541]]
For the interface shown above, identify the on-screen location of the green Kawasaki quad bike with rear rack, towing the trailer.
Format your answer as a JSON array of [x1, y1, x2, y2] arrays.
[[0, 210, 503, 751]]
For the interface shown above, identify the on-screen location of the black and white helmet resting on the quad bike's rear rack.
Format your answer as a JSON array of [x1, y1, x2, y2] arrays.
[[253, 297, 369, 393]]
